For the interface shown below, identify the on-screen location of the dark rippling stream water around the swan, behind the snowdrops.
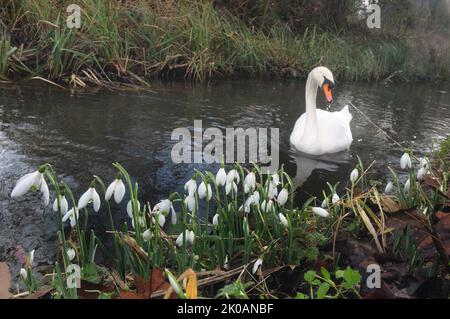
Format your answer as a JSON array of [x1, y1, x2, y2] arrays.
[[0, 81, 450, 273]]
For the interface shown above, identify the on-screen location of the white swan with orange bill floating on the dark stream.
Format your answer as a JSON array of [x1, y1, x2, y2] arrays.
[[290, 66, 353, 155]]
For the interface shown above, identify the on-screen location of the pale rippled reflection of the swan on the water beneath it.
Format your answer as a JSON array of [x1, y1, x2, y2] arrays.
[[289, 148, 351, 189]]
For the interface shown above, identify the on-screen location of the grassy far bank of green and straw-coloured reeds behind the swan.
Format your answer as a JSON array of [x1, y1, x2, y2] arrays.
[[0, 0, 450, 87]]
